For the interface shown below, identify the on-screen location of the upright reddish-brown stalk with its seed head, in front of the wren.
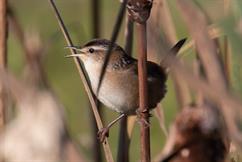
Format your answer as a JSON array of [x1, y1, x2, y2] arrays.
[[127, 0, 153, 162]]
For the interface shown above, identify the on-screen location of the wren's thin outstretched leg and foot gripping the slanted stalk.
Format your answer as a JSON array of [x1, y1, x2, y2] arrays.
[[98, 114, 125, 142]]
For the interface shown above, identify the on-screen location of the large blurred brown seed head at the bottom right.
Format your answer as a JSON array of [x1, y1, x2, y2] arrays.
[[161, 105, 229, 162]]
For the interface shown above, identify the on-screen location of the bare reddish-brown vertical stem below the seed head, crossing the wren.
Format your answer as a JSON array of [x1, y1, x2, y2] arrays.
[[137, 22, 150, 162]]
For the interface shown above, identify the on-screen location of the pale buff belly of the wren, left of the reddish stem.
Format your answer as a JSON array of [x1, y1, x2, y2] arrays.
[[89, 73, 138, 113]]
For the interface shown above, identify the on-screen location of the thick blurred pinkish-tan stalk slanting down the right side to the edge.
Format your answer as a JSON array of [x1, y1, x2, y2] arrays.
[[177, 0, 242, 151]]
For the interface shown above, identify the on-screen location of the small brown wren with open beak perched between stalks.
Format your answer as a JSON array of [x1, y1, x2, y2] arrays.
[[67, 39, 184, 140]]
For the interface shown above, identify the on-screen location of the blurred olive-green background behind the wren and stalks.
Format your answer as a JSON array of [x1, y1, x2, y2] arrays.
[[8, 0, 242, 162]]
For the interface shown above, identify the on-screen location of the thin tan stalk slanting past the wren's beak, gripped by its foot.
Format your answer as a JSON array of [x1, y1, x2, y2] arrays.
[[49, 0, 114, 162]]
